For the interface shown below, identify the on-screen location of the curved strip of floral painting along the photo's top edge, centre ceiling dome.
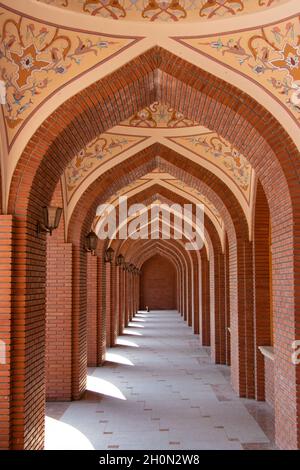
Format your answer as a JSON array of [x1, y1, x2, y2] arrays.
[[37, 0, 288, 22]]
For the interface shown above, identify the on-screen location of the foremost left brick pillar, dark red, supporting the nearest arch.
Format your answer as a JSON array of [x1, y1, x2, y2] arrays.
[[11, 216, 46, 450]]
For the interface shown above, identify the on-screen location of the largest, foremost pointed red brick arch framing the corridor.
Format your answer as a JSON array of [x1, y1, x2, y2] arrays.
[[8, 47, 300, 448]]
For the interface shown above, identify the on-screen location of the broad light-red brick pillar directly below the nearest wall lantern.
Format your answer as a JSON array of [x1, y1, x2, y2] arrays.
[[46, 235, 72, 401]]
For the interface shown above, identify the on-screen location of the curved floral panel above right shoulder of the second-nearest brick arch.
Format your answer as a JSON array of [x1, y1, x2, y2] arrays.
[[171, 132, 252, 200]]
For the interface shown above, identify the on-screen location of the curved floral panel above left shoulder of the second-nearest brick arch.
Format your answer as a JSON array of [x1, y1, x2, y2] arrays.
[[65, 133, 145, 201]]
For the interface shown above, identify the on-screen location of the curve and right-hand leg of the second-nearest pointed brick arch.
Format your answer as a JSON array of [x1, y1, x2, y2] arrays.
[[68, 155, 254, 397]]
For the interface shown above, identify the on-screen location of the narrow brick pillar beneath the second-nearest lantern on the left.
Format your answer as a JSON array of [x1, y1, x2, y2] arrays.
[[87, 254, 100, 367]]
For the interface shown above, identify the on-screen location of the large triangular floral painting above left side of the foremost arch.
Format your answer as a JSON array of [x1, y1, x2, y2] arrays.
[[0, 5, 140, 143]]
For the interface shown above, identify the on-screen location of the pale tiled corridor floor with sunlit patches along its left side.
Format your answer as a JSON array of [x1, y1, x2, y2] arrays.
[[46, 311, 274, 450]]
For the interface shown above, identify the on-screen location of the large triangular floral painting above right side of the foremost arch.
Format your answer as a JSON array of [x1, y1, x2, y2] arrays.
[[174, 16, 300, 123]]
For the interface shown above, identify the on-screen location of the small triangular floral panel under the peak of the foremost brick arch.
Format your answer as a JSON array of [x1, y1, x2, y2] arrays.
[[121, 101, 198, 128]]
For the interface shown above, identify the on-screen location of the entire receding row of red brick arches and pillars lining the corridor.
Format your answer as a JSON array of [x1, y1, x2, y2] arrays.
[[0, 48, 300, 449]]
